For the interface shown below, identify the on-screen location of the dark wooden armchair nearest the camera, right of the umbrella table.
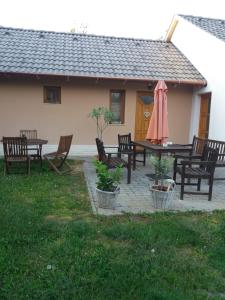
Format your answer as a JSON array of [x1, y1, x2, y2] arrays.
[[173, 145, 219, 201]]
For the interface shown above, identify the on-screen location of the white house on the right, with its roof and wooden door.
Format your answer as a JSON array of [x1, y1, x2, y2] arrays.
[[166, 15, 225, 140]]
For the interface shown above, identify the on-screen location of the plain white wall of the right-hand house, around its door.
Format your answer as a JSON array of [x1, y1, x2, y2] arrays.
[[171, 17, 225, 140]]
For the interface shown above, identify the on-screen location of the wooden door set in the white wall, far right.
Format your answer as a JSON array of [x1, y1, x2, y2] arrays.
[[198, 93, 211, 139]]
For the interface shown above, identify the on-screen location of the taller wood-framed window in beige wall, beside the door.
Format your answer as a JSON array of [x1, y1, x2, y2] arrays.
[[110, 90, 125, 124]]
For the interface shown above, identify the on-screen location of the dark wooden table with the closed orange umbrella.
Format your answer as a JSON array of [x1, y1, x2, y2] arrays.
[[133, 141, 192, 170]]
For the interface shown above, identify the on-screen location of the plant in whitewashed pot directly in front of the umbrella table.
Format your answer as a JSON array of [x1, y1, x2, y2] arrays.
[[150, 156, 175, 209]]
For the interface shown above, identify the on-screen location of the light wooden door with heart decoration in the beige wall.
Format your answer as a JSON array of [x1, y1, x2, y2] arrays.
[[134, 92, 154, 141]]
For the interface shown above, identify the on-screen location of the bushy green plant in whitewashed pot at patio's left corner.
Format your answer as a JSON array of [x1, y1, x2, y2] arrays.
[[94, 160, 123, 209]]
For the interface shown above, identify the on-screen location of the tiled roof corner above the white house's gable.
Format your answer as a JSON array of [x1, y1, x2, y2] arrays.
[[180, 15, 225, 42]]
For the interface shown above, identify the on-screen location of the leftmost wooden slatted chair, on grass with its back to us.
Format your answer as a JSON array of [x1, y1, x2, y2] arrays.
[[2, 137, 30, 175]]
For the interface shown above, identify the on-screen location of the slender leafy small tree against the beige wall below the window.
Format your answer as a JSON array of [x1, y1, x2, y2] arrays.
[[89, 107, 114, 140]]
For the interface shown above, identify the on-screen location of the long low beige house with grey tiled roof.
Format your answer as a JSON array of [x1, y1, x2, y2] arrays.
[[0, 27, 206, 155]]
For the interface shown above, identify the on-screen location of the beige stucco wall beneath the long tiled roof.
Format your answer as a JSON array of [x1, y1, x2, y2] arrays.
[[0, 79, 192, 152]]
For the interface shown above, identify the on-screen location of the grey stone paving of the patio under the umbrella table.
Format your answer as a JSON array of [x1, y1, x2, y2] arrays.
[[83, 157, 225, 215]]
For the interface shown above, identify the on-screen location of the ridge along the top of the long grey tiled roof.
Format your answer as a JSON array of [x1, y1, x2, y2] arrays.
[[0, 26, 168, 43]]
